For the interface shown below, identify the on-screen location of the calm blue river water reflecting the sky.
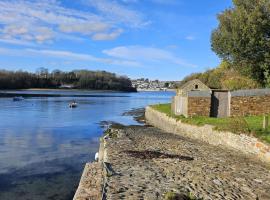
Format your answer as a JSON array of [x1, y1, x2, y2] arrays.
[[0, 91, 174, 200]]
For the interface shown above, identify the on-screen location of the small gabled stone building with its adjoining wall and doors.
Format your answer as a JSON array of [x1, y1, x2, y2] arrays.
[[171, 79, 270, 117]]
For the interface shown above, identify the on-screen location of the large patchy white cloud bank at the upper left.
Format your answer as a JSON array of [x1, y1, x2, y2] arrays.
[[0, 0, 147, 43]]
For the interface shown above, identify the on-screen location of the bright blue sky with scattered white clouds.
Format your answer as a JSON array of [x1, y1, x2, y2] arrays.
[[0, 0, 232, 80]]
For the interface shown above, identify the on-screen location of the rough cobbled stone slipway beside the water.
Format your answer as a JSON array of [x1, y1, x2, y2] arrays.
[[105, 126, 270, 200]]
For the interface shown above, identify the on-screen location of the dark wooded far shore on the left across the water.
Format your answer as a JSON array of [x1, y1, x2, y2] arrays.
[[0, 68, 135, 91]]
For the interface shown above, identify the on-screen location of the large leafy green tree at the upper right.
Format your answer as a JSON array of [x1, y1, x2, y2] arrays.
[[211, 0, 270, 86]]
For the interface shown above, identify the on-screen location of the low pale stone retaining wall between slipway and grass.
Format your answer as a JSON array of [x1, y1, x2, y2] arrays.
[[145, 106, 270, 163]]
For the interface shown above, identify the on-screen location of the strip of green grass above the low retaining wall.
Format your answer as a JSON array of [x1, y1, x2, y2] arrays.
[[152, 104, 270, 144]]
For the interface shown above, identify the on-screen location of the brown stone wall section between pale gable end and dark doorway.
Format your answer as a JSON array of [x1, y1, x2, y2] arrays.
[[187, 97, 211, 117]]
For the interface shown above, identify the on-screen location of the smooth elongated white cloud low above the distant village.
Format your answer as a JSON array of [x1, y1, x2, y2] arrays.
[[103, 46, 195, 67]]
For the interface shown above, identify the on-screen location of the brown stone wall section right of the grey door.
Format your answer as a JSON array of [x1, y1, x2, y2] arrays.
[[230, 95, 270, 116]]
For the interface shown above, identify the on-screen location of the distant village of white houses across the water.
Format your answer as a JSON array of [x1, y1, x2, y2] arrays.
[[131, 78, 179, 91]]
